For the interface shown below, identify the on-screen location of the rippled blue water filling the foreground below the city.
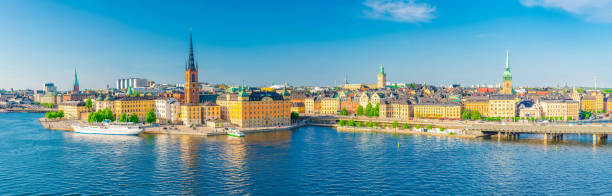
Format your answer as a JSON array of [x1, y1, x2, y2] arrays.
[[0, 114, 612, 195]]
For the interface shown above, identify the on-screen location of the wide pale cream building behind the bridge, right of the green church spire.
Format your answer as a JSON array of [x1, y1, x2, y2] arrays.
[[539, 99, 580, 120]]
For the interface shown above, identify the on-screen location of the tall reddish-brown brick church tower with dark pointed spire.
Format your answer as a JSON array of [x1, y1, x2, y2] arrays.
[[185, 33, 200, 104]]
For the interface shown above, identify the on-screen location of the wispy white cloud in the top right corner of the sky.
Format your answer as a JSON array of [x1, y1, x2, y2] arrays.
[[520, 0, 612, 23]]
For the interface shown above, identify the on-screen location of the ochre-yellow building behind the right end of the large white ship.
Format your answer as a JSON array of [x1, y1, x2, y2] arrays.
[[115, 97, 155, 121]]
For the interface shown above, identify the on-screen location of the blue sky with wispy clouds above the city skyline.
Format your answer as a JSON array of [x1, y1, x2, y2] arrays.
[[0, 0, 612, 89]]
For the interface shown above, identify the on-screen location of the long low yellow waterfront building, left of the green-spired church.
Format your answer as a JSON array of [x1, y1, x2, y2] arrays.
[[413, 103, 461, 119]]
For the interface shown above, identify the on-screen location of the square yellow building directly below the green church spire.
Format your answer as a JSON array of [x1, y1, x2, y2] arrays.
[[488, 95, 518, 118]]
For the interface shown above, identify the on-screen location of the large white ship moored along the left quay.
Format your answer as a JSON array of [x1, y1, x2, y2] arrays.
[[72, 122, 144, 135]]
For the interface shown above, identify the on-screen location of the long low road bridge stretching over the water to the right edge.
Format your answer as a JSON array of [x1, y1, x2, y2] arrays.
[[310, 115, 612, 143]]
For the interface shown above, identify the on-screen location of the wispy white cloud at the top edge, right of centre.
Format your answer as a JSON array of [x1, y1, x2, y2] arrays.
[[364, 0, 436, 23]]
